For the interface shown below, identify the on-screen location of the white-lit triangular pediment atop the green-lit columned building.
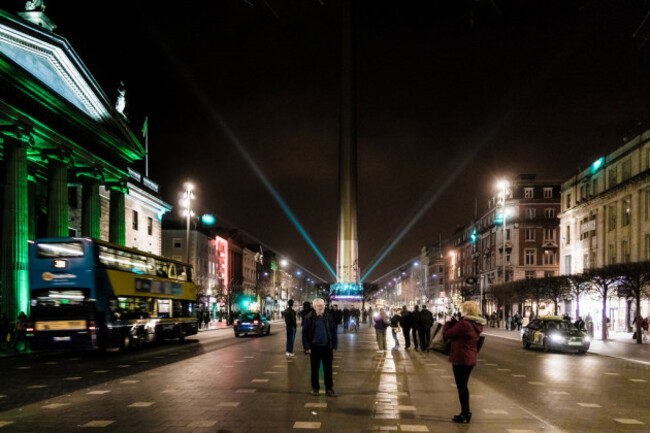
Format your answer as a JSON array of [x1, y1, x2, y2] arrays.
[[0, 12, 112, 121]]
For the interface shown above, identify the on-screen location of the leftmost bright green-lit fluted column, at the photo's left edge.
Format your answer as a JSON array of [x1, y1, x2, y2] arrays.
[[0, 137, 29, 321]]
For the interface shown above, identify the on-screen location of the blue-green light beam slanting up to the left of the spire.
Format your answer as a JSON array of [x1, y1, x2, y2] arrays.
[[150, 40, 338, 280]]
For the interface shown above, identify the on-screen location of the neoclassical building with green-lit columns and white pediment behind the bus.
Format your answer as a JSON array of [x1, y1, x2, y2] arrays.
[[0, 5, 170, 320]]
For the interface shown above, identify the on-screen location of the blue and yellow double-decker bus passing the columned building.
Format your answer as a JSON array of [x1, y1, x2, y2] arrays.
[[28, 238, 198, 350]]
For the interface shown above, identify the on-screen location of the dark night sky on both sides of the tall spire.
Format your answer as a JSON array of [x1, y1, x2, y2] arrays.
[[11, 0, 650, 281]]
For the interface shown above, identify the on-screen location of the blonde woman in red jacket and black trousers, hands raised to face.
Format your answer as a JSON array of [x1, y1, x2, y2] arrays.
[[442, 301, 486, 423]]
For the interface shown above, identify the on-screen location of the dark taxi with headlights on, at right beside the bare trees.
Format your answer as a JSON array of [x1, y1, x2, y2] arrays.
[[521, 316, 591, 353]]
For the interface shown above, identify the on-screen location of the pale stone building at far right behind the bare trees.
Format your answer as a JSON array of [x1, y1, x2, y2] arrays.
[[559, 131, 650, 329]]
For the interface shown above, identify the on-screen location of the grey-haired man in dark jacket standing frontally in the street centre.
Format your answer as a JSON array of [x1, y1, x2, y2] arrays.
[[302, 298, 339, 397]]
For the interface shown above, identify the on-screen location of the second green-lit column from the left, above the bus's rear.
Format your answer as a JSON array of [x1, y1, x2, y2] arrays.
[[47, 155, 69, 238]]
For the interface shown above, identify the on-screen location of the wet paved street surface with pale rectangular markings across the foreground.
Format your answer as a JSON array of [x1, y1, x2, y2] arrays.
[[0, 324, 650, 433]]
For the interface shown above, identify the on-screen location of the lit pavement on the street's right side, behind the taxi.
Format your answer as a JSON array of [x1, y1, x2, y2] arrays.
[[483, 327, 650, 365]]
